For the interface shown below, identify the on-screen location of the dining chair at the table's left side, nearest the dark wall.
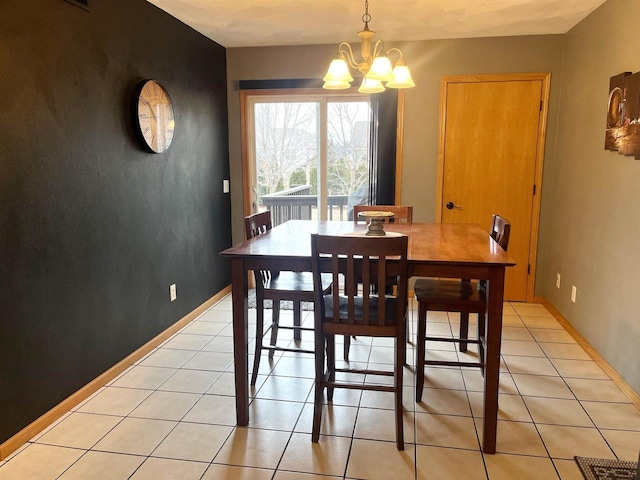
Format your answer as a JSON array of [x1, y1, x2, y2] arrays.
[[244, 210, 331, 385]]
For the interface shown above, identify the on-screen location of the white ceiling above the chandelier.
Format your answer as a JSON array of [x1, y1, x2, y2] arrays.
[[148, 0, 605, 48]]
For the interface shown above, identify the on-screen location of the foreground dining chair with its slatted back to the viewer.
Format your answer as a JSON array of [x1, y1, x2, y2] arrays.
[[311, 234, 408, 450]]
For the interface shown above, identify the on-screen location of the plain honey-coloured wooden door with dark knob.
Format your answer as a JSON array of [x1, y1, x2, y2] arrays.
[[436, 74, 549, 301]]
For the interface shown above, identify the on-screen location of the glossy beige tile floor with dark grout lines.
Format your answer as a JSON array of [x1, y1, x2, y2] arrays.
[[0, 298, 640, 480]]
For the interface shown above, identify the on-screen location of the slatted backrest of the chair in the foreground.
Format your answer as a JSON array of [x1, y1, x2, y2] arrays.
[[311, 234, 408, 328]]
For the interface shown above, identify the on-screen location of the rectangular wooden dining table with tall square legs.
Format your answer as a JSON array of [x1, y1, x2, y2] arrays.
[[220, 220, 515, 453]]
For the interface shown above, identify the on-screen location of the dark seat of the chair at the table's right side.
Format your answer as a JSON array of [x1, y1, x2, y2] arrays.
[[413, 278, 485, 313]]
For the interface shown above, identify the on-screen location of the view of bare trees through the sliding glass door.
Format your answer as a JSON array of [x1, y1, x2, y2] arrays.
[[254, 101, 370, 201]]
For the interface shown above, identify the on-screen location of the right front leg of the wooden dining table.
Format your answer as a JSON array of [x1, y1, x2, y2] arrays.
[[482, 267, 504, 453]]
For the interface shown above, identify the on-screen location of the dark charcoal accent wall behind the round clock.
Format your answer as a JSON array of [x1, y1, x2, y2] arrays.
[[0, 0, 231, 443]]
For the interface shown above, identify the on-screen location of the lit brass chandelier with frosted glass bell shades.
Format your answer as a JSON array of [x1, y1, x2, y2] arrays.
[[322, 0, 416, 93]]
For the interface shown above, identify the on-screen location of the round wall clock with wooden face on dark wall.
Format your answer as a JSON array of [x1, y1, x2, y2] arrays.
[[131, 80, 175, 153]]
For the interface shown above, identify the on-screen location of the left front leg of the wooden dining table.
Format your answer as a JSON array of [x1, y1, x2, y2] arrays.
[[231, 258, 249, 426]]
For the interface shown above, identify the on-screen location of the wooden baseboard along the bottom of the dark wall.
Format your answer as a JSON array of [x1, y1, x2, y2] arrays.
[[0, 286, 231, 460]]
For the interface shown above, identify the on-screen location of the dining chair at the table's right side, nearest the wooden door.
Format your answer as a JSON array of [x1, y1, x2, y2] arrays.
[[413, 215, 511, 402]]
